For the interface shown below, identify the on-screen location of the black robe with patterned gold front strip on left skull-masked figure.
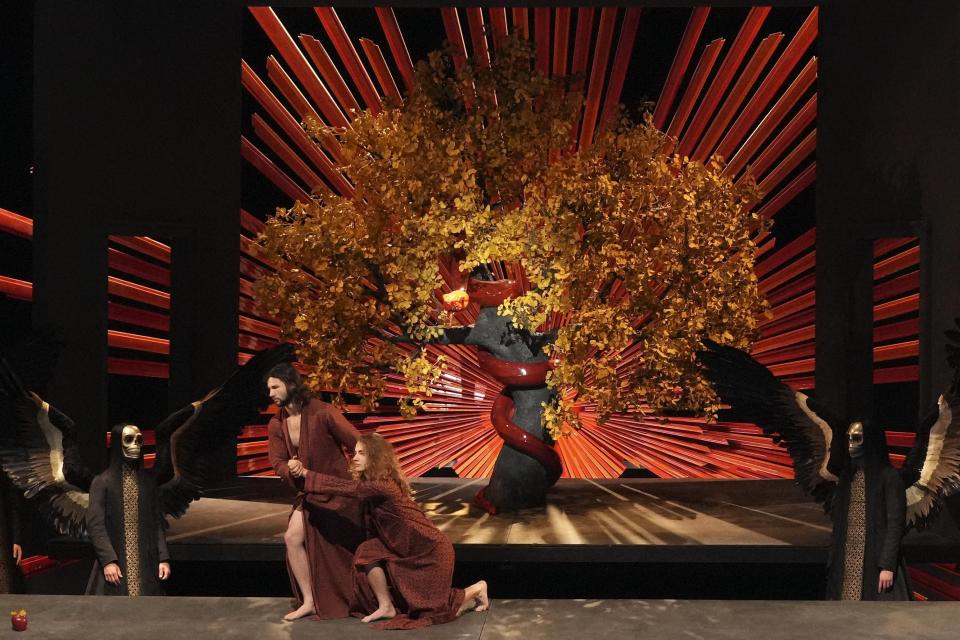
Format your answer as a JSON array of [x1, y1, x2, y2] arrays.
[[86, 464, 170, 596]]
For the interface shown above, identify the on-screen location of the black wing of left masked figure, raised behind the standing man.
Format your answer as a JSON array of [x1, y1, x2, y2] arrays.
[[155, 344, 293, 518]]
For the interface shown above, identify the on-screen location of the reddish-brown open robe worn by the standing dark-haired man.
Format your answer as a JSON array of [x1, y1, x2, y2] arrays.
[[267, 399, 363, 620]]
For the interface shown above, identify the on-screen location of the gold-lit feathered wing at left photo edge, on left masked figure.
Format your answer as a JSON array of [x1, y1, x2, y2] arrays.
[[0, 360, 92, 537]]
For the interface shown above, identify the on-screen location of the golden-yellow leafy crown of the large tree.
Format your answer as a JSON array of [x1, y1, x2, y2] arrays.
[[256, 39, 765, 436]]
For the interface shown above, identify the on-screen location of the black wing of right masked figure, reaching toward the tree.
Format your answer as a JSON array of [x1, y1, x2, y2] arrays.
[[697, 339, 842, 509]]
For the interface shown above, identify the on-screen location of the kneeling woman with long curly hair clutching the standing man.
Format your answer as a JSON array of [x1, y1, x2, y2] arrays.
[[300, 434, 489, 629]]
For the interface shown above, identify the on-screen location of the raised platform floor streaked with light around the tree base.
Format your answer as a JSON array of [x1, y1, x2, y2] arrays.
[[116, 478, 960, 563]]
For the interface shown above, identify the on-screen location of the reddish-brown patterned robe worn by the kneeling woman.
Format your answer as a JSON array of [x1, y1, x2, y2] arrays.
[[305, 470, 464, 629]]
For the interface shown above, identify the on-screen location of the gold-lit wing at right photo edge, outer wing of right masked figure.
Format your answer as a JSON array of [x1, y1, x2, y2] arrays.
[[901, 393, 960, 529]]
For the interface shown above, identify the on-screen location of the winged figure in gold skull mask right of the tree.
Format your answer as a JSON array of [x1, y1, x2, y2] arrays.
[[698, 324, 960, 600]]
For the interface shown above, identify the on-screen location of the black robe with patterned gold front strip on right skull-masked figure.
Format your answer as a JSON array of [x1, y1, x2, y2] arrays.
[[827, 464, 911, 600]]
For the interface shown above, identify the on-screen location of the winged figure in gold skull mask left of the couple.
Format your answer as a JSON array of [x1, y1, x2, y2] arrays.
[[0, 344, 293, 595]]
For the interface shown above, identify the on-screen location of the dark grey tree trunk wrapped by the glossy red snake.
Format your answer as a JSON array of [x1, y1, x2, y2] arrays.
[[466, 307, 555, 512]]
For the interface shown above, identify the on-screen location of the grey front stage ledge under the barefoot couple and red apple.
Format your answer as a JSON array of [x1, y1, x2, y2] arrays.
[[0, 595, 957, 640]]
